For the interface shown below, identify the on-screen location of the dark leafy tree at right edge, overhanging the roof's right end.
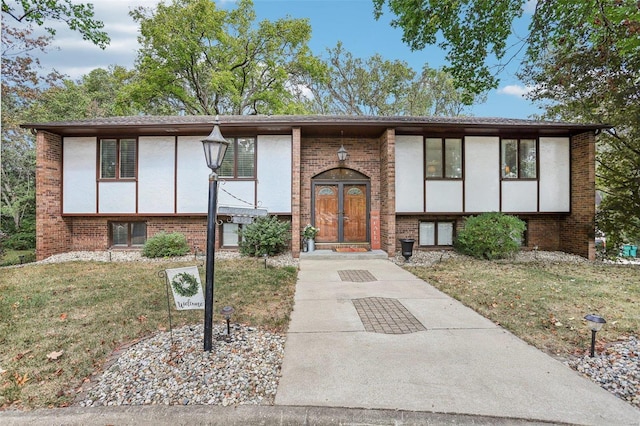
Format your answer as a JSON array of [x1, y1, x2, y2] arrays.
[[521, 1, 640, 251]]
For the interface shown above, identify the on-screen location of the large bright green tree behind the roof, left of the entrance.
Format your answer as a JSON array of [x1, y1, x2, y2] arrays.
[[131, 0, 319, 114]]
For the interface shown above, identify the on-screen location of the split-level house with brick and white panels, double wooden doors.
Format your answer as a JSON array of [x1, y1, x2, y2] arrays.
[[23, 115, 603, 259]]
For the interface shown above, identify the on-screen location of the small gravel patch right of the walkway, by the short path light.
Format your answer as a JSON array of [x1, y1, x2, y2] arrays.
[[567, 336, 640, 408]]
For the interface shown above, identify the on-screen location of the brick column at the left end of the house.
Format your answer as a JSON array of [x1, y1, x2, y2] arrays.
[[36, 131, 71, 260]]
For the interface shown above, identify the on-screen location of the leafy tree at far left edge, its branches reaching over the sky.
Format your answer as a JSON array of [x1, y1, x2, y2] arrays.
[[0, 0, 109, 241]]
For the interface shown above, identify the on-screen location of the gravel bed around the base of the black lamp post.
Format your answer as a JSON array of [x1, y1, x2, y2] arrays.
[[76, 324, 285, 407]]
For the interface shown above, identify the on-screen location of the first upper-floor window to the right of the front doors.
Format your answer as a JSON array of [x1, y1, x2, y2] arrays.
[[425, 138, 462, 179]]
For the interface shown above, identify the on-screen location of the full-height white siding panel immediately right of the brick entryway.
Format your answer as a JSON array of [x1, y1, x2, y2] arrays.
[[395, 136, 424, 213]]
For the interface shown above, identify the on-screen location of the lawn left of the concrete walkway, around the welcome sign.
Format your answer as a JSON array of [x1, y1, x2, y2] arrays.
[[0, 259, 296, 408]]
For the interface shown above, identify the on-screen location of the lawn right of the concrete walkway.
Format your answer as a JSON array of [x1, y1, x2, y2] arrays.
[[407, 257, 640, 357]]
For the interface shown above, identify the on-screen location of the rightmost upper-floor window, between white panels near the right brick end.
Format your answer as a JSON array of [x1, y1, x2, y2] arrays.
[[500, 139, 538, 179]]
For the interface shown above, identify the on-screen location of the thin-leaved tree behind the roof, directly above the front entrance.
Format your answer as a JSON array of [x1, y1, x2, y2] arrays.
[[304, 42, 464, 116]]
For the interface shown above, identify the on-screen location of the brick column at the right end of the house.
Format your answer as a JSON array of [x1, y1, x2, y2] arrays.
[[560, 132, 596, 260]]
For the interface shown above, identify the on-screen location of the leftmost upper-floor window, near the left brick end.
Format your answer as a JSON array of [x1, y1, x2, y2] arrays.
[[100, 139, 137, 179]]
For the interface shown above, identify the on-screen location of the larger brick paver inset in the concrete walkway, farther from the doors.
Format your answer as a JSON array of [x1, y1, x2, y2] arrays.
[[352, 297, 426, 334]]
